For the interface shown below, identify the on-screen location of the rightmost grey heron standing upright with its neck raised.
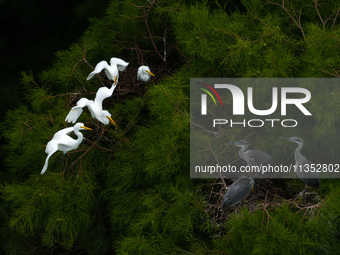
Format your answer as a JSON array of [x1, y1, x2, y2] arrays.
[[280, 136, 320, 199]]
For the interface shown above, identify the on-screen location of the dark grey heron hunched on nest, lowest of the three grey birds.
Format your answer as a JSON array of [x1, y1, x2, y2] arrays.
[[222, 176, 255, 209]]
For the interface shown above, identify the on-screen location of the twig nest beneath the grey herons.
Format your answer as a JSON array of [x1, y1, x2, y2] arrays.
[[203, 179, 321, 226]]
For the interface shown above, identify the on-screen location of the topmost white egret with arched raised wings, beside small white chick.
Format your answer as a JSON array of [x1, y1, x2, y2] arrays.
[[87, 58, 129, 81]]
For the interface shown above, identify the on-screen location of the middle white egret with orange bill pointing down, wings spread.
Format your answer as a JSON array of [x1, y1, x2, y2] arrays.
[[65, 76, 117, 126]]
